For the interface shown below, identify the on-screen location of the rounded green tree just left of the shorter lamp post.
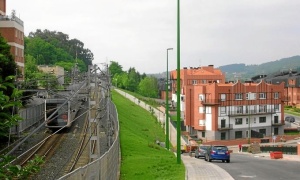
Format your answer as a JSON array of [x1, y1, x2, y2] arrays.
[[138, 77, 158, 98]]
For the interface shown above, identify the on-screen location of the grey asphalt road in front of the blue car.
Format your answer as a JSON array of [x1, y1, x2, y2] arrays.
[[212, 153, 300, 180]]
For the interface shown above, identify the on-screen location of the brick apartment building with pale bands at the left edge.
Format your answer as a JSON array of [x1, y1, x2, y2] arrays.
[[0, 0, 25, 80]]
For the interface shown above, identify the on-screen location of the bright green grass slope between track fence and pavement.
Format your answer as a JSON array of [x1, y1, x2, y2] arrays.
[[112, 91, 185, 180]]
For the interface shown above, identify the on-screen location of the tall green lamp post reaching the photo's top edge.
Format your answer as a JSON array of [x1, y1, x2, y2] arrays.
[[176, 0, 181, 164]]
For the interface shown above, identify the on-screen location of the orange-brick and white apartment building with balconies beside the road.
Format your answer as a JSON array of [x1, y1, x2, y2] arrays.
[[171, 65, 284, 140]]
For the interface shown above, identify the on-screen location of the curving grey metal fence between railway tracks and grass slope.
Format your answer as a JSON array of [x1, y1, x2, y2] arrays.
[[59, 102, 120, 180]]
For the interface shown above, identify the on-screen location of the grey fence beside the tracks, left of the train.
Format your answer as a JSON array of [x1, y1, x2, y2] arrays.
[[11, 103, 44, 134]]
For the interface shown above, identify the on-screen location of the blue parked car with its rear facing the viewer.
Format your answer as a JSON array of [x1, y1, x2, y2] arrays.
[[204, 145, 230, 163]]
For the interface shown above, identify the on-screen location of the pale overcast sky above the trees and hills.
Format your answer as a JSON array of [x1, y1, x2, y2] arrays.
[[6, 0, 300, 74]]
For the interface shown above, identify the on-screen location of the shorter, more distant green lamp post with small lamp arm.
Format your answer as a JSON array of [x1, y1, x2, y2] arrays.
[[166, 48, 173, 150]]
